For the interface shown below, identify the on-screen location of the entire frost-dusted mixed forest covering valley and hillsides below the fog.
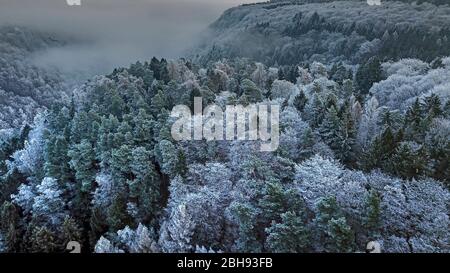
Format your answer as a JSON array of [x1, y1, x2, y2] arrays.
[[0, 0, 450, 253]]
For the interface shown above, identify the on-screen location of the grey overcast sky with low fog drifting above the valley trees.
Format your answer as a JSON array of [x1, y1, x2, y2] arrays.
[[0, 0, 259, 73]]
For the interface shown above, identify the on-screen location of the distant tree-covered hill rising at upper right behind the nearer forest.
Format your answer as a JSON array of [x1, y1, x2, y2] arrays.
[[194, 0, 450, 65]]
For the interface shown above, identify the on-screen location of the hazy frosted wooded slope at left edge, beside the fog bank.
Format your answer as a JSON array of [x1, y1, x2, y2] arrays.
[[0, 26, 68, 129]]
